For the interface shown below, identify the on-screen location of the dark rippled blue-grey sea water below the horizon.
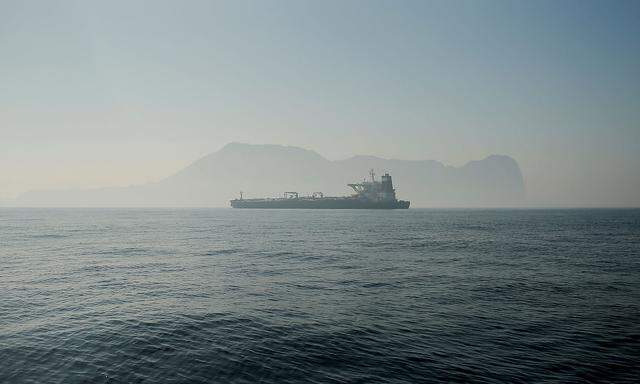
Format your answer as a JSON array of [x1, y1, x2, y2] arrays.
[[0, 209, 640, 383]]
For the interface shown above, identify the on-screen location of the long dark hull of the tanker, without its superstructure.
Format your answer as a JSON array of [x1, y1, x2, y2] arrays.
[[231, 199, 409, 209]]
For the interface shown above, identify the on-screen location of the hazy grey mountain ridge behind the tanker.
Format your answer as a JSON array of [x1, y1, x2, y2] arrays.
[[15, 143, 525, 207]]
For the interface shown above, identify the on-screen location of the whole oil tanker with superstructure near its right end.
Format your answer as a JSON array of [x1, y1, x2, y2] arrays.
[[231, 170, 410, 209]]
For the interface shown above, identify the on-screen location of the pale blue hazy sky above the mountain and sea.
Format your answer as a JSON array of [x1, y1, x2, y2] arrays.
[[0, 0, 640, 206]]
